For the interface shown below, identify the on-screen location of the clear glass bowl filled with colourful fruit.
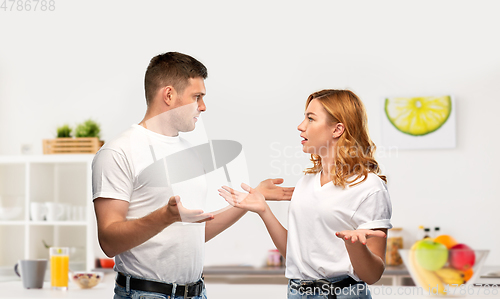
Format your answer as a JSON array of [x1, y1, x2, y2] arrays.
[[399, 235, 489, 296]]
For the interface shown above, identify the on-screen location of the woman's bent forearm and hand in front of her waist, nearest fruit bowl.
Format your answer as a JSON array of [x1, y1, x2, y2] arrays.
[[335, 228, 387, 284]]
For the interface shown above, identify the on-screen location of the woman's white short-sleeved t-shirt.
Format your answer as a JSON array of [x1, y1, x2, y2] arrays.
[[285, 173, 392, 280]]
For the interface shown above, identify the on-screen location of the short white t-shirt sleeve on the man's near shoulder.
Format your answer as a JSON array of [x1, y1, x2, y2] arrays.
[[92, 149, 133, 202]]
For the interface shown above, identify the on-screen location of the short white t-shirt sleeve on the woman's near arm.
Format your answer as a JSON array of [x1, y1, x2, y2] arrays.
[[352, 190, 392, 229]]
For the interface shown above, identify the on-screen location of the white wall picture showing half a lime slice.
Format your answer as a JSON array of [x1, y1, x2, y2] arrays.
[[382, 95, 456, 149]]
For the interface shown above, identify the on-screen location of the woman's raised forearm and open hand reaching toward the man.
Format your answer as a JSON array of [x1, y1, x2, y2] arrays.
[[219, 184, 287, 258]]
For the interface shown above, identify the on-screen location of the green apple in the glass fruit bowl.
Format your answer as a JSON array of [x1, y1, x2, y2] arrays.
[[415, 238, 448, 271]]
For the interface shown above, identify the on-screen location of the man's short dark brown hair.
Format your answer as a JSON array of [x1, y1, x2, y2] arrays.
[[144, 52, 208, 105]]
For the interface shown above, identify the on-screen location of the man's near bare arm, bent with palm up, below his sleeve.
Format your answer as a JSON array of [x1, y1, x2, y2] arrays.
[[94, 196, 213, 257]]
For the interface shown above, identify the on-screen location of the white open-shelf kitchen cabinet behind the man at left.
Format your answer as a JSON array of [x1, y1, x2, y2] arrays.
[[0, 154, 97, 274]]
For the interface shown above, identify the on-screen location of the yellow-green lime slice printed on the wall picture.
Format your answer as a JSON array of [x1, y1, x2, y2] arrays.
[[385, 96, 451, 136]]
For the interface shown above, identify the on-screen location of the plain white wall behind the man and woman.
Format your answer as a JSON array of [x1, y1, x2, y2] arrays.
[[0, 0, 500, 265]]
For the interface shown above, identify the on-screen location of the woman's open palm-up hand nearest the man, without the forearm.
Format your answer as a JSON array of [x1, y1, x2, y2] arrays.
[[219, 184, 268, 215]]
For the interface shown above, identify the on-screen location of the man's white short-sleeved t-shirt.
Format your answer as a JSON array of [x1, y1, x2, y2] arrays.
[[92, 125, 207, 284]]
